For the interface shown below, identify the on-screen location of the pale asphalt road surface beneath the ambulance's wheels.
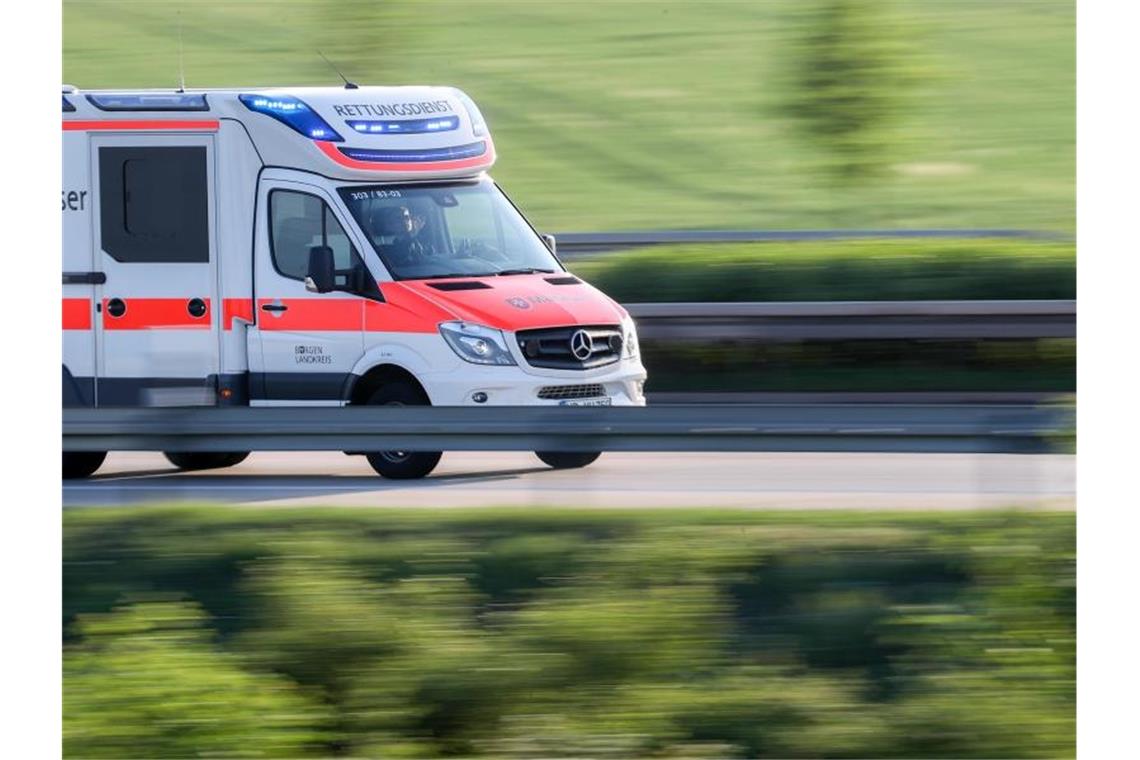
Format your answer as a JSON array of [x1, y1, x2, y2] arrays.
[[63, 452, 1076, 509]]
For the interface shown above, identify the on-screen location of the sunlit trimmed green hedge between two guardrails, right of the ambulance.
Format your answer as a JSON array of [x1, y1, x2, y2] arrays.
[[569, 239, 1076, 303]]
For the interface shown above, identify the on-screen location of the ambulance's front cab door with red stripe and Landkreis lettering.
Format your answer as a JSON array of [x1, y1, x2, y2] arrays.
[[250, 180, 378, 406]]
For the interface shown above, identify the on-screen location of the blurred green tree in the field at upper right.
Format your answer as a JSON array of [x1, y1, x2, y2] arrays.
[[787, 0, 917, 185]]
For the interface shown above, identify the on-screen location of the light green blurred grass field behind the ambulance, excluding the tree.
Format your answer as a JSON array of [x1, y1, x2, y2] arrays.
[[64, 0, 1075, 232]]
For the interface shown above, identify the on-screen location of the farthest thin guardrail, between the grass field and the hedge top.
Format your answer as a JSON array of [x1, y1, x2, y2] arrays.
[[555, 229, 1072, 259]]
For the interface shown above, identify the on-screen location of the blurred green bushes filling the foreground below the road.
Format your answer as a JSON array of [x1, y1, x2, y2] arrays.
[[64, 507, 1076, 758]]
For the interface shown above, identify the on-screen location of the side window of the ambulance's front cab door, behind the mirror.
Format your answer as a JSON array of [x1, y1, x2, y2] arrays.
[[269, 190, 366, 288]]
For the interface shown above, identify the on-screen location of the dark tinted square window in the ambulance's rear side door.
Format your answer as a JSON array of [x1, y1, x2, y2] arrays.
[[99, 146, 210, 263]]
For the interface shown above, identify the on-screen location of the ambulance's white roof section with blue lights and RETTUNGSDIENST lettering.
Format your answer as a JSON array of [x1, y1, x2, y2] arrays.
[[63, 87, 495, 181]]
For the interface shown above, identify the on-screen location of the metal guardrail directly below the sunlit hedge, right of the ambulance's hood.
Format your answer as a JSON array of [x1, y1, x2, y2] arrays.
[[625, 301, 1076, 342]]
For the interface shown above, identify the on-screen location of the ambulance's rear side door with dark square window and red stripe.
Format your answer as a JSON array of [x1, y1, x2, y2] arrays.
[[91, 134, 221, 406]]
